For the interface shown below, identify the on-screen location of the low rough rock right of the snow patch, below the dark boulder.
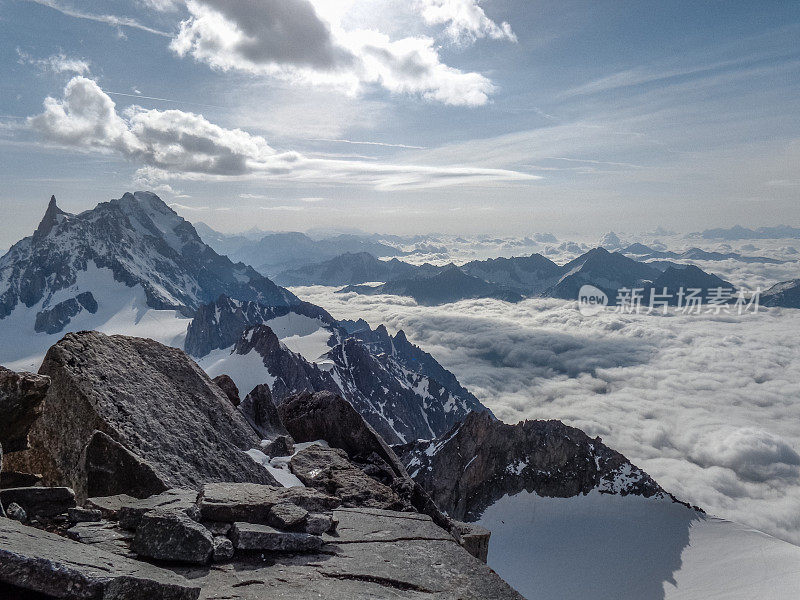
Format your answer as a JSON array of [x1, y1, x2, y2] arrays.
[[289, 445, 410, 510]]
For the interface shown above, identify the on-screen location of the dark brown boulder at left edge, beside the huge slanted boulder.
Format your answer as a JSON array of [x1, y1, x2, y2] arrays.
[[0, 367, 50, 454]]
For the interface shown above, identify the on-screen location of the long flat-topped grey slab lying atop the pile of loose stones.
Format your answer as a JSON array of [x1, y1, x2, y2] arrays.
[[199, 483, 341, 524]]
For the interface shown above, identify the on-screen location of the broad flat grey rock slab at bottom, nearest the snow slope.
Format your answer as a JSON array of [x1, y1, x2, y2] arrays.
[[167, 509, 522, 600]]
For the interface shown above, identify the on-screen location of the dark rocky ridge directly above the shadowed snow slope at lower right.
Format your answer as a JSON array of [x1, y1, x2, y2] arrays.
[[394, 413, 688, 521]]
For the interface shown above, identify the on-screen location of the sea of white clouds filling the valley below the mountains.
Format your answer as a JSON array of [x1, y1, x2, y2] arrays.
[[294, 288, 800, 544]]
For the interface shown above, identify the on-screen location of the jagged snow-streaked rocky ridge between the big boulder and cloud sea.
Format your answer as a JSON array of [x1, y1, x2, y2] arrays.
[[186, 298, 487, 443]]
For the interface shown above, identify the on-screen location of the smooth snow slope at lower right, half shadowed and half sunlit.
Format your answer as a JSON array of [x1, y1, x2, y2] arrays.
[[479, 491, 800, 600]]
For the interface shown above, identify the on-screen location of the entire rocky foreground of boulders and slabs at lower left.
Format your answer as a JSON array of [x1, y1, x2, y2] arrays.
[[0, 332, 521, 600]]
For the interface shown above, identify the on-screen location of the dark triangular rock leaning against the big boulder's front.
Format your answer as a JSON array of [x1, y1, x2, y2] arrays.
[[82, 431, 167, 498]]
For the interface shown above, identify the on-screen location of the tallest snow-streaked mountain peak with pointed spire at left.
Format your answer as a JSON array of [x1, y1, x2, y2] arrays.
[[0, 192, 299, 333]]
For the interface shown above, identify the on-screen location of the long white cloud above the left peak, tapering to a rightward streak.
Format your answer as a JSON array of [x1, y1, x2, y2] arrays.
[[28, 76, 536, 189]]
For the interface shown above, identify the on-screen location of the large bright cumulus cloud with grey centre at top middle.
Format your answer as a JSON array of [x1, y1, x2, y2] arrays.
[[170, 0, 495, 106]]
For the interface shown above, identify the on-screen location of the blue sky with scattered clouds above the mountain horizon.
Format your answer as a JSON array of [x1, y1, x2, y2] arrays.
[[0, 0, 800, 248]]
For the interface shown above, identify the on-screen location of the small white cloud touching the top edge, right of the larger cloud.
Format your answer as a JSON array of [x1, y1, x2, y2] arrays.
[[416, 0, 517, 44]]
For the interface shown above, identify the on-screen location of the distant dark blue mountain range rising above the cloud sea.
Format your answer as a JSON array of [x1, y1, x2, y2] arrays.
[[275, 248, 733, 305]]
